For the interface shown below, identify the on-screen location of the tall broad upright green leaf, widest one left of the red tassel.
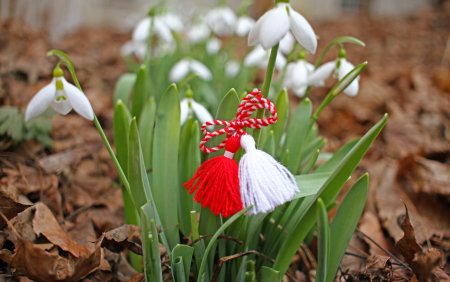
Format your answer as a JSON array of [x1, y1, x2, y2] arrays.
[[152, 84, 180, 250]]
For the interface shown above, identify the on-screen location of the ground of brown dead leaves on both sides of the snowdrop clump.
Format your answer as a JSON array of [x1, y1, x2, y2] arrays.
[[0, 3, 450, 281]]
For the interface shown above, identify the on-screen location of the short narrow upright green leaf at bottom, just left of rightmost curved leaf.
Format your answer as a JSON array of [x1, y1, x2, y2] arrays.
[[316, 198, 328, 281]]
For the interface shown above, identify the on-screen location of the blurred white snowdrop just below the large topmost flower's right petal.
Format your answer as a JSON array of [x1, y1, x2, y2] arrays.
[[283, 59, 316, 97]]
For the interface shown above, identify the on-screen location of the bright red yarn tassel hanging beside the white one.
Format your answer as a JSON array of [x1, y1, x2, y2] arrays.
[[184, 135, 242, 217]]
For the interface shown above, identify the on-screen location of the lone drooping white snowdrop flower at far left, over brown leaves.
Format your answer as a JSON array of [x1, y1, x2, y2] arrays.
[[25, 67, 94, 121]]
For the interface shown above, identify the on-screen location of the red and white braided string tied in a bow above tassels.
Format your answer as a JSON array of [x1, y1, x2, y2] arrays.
[[200, 89, 278, 153]]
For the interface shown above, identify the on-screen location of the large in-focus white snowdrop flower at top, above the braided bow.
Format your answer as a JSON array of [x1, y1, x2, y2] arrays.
[[248, 3, 317, 53]]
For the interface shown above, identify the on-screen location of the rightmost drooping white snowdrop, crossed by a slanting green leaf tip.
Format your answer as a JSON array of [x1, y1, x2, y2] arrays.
[[308, 57, 359, 97]]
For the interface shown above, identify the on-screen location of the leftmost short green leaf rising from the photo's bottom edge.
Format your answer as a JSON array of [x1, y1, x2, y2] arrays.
[[141, 204, 163, 282]]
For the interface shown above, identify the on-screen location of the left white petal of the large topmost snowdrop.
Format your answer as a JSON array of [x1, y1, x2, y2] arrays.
[[249, 4, 289, 50]]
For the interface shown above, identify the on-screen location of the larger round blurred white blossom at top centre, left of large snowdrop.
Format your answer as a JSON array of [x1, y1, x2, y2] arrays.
[[206, 6, 237, 36]]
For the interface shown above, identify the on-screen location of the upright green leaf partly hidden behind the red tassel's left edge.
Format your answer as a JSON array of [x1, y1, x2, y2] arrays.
[[179, 118, 201, 236]]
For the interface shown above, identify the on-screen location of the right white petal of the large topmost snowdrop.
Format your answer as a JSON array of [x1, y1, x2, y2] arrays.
[[289, 8, 317, 54]]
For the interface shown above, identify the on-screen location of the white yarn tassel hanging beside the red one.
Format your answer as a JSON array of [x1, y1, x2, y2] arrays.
[[239, 134, 299, 214]]
